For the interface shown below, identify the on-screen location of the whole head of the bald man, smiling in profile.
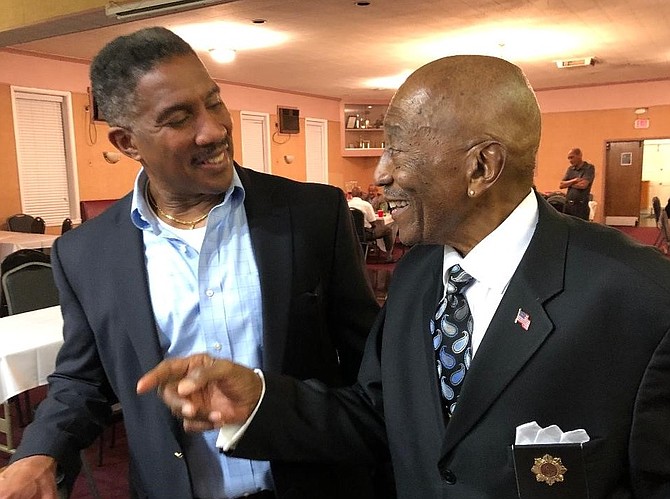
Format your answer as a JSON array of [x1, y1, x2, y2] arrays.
[[375, 56, 540, 255]]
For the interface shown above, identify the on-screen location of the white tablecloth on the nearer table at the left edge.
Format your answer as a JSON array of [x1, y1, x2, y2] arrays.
[[0, 306, 63, 402]]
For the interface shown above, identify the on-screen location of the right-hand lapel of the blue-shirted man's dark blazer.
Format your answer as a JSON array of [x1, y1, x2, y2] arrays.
[[237, 167, 293, 370]]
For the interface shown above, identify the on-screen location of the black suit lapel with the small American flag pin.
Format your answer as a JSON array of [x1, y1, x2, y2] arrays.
[[442, 195, 568, 454]]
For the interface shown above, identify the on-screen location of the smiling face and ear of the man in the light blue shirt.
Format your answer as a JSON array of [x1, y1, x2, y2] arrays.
[[110, 55, 233, 200]]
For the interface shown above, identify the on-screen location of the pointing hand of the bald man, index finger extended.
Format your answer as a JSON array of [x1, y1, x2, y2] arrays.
[[137, 354, 262, 431]]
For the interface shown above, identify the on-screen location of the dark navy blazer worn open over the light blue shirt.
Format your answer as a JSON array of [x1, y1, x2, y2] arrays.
[[14, 166, 378, 499]]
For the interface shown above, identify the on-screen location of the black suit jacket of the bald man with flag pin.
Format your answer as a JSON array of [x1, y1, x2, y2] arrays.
[[235, 196, 670, 499]]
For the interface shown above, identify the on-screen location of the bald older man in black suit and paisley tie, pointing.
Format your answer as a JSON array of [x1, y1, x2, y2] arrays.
[[138, 56, 670, 499]]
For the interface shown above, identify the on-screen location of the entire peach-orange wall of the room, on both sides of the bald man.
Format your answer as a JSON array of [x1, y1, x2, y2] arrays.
[[0, 49, 670, 227]]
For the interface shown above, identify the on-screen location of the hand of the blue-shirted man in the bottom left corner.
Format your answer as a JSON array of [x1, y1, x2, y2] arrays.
[[0, 456, 58, 499]]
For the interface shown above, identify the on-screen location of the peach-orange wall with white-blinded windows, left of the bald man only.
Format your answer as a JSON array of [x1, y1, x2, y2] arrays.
[[0, 49, 370, 226]]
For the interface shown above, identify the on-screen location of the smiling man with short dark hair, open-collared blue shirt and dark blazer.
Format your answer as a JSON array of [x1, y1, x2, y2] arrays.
[[0, 28, 386, 499]]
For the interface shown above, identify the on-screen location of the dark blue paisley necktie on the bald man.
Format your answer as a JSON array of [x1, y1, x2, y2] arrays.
[[430, 265, 473, 417]]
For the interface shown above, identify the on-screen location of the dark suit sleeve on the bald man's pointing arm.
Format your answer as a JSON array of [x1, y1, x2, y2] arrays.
[[229, 310, 389, 464]]
